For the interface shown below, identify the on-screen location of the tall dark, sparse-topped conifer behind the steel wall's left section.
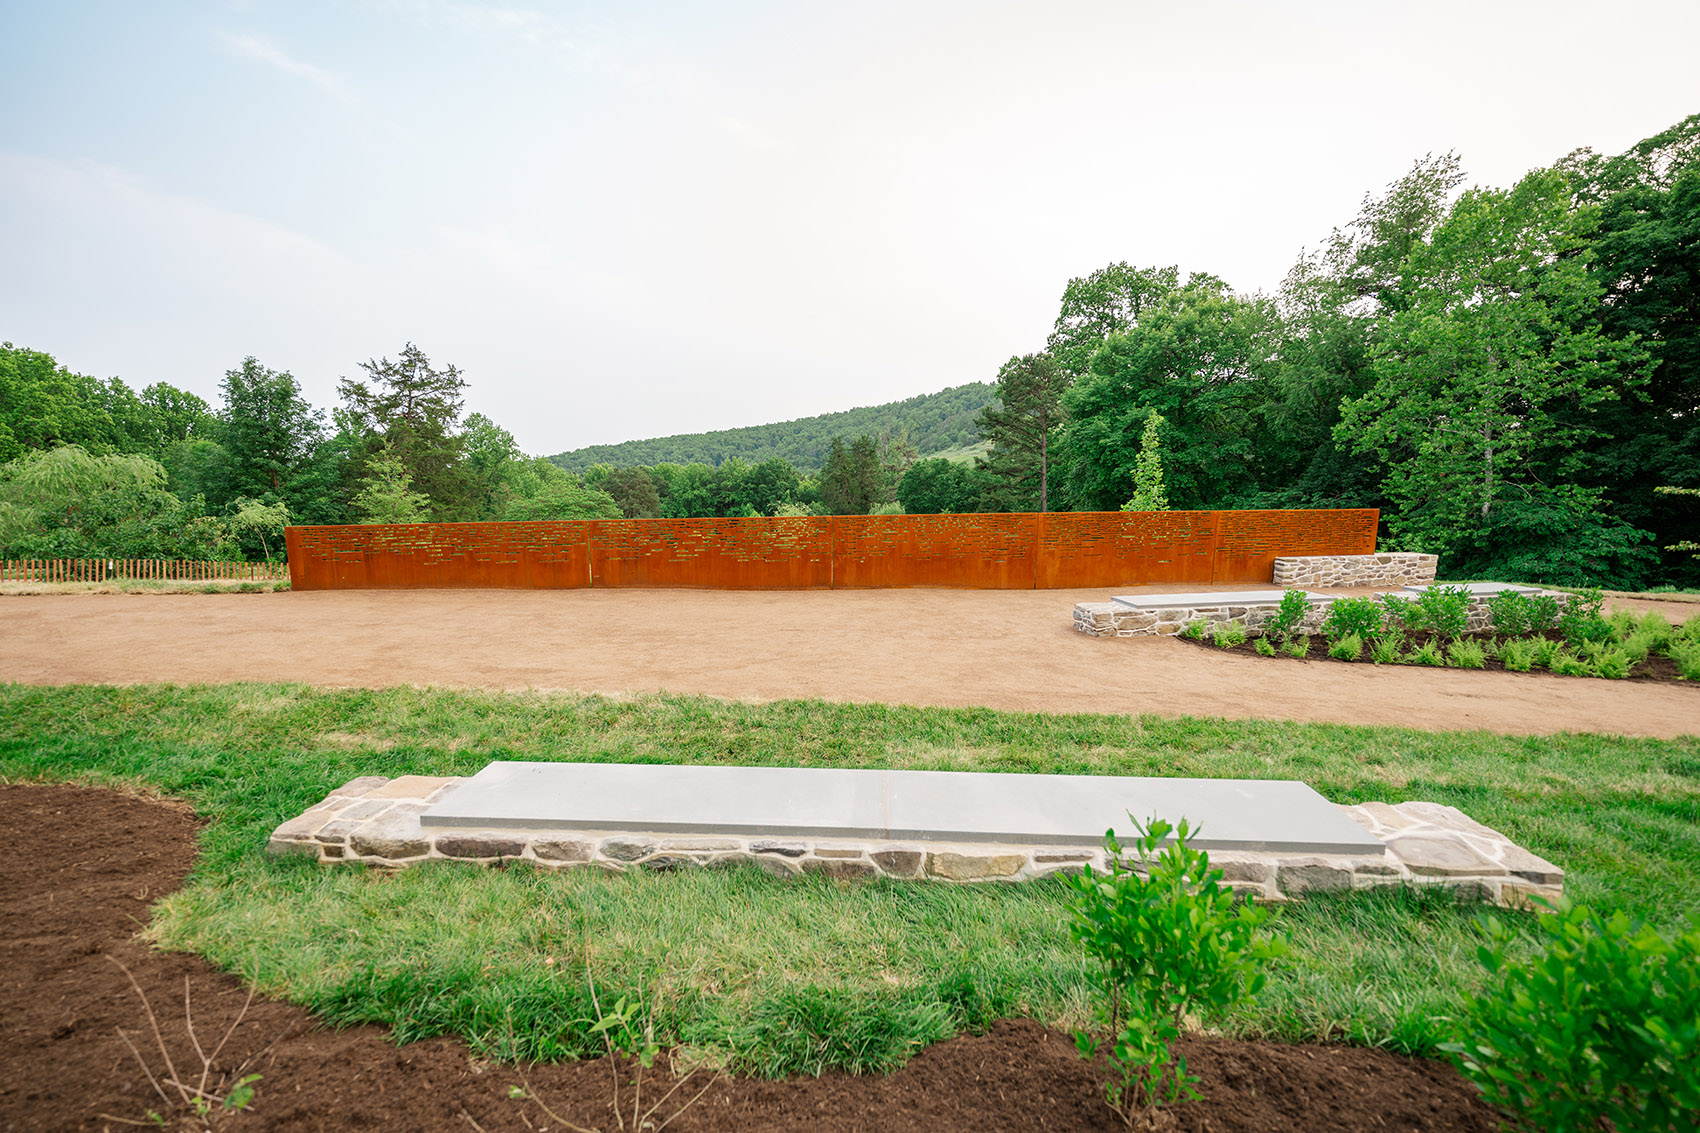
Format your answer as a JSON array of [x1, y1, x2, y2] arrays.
[[337, 342, 476, 521]]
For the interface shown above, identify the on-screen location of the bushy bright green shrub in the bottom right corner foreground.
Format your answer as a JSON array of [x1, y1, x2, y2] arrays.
[[1443, 905, 1700, 1131]]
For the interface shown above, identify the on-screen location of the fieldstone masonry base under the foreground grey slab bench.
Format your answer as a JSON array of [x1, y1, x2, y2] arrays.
[[269, 776, 1564, 905]]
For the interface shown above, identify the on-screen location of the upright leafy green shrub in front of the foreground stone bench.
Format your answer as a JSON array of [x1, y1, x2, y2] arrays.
[[1068, 818, 1285, 1124]]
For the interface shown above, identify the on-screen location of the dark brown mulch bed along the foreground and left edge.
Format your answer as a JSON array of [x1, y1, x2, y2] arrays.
[[0, 786, 1496, 1133]]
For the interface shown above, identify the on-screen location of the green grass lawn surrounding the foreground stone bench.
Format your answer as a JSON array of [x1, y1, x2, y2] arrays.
[[0, 684, 1700, 1073]]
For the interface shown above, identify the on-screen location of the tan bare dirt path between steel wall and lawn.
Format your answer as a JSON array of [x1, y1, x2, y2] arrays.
[[0, 587, 1700, 737]]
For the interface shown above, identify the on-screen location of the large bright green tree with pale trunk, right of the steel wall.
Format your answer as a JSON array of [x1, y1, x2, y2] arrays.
[[1336, 170, 1646, 568]]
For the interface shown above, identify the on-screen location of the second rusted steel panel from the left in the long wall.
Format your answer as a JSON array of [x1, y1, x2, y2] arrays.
[[590, 515, 833, 590]]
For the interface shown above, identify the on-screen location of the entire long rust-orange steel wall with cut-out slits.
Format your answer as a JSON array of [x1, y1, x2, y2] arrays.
[[286, 509, 1379, 590]]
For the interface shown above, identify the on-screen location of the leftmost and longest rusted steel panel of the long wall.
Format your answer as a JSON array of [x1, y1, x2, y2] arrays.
[[284, 521, 590, 590]]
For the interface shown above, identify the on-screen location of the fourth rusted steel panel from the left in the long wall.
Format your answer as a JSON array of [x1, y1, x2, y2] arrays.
[[1037, 512, 1217, 589]]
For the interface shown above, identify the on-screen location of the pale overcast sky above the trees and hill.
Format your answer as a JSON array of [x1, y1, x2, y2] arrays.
[[0, 0, 1700, 453]]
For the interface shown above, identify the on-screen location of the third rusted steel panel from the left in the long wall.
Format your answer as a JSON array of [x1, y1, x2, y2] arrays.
[[833, 514, 1039, 590]]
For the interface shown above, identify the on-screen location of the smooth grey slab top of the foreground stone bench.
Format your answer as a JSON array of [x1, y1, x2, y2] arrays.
[[420, 762, 1382, 854]]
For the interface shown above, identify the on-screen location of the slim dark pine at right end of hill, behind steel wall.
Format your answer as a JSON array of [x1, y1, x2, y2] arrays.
[[976, 354, 1069, 512]]
